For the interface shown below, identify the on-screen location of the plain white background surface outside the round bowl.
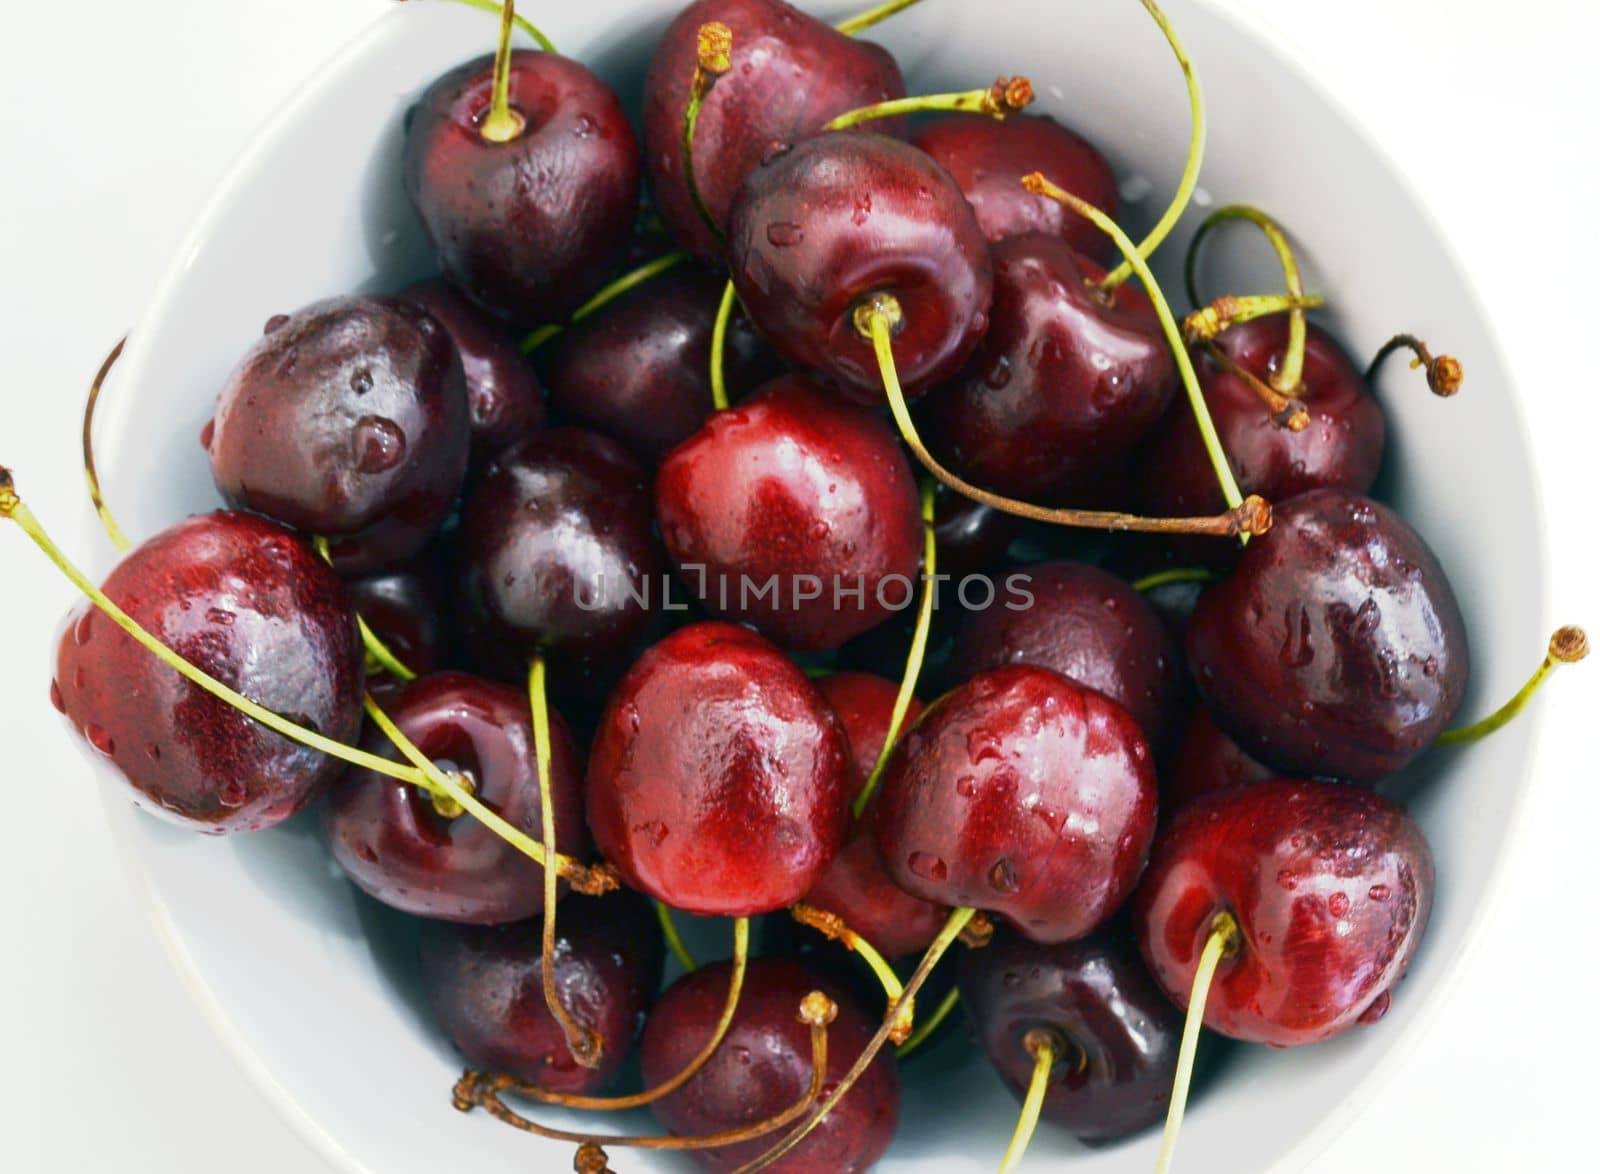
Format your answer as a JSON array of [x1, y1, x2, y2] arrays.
[[0, 0, 1600, 1174]]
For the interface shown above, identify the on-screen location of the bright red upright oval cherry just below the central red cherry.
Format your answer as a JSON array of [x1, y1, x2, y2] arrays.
[[587, 624, 853, 916]]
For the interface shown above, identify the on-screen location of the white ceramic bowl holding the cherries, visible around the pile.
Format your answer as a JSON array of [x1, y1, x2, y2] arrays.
[[82, 0, 1547, 1174]]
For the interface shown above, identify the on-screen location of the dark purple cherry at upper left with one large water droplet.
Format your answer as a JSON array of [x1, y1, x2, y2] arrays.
[[202, 297, 469, 574]]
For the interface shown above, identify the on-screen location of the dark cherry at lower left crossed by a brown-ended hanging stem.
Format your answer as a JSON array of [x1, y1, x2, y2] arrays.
[[418, 889, 666, 1096]]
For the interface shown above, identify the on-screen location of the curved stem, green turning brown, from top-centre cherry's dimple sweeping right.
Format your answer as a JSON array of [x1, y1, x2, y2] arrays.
[[856, 294, 1272, 537]]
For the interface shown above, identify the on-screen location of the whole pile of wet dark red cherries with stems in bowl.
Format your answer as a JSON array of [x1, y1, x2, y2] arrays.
[[12, 0, 1582, 1171]]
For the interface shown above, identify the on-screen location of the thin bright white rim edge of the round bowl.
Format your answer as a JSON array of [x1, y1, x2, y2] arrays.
[[93, 0, 1552, 1174]]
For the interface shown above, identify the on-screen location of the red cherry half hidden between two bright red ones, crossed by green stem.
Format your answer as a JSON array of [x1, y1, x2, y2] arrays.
[[805, 673, 949, 958]]
